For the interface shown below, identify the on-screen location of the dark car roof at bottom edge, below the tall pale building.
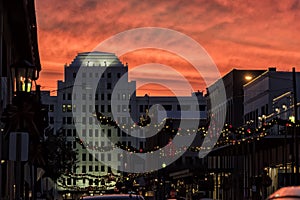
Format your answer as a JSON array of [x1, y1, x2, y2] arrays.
[[82, 194, 145, 200]]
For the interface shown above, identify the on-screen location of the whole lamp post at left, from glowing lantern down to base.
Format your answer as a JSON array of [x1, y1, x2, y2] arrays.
[[7, 60, 38, 200]]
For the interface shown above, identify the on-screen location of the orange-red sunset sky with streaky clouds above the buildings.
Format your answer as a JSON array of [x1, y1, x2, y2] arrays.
[[36, 0, 300, 95]]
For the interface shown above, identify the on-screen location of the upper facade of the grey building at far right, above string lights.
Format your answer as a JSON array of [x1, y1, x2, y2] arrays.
[[244, 68, 300, 127]]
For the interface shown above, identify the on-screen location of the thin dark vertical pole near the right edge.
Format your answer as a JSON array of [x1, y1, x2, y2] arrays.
[[293, 67, 299, 185]]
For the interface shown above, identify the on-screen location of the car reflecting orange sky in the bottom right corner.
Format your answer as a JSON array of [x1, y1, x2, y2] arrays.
[[267, 186, 300, 200]]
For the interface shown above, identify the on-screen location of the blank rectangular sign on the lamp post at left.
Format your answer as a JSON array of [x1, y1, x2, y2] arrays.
[[9, 132, 29, 161]]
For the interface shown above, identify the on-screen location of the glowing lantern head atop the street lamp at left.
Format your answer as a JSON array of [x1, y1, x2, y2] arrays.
[[11, 60, 38, 94]]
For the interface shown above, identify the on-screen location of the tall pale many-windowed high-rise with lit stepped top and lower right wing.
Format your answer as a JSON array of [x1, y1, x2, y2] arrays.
[[42, 52, 206, 193]]
